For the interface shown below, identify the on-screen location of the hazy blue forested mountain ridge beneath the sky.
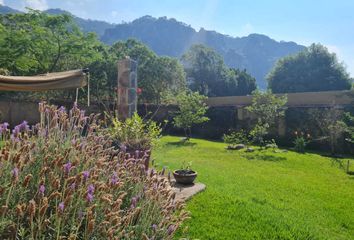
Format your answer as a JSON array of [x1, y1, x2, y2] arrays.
[[0, 5, 305, 89]]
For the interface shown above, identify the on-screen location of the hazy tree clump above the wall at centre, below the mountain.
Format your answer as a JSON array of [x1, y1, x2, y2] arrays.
[[182, 45, 256, 97]]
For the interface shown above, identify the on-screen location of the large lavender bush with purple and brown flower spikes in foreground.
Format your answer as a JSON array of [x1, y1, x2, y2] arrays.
[[0, 104, 187, 239]]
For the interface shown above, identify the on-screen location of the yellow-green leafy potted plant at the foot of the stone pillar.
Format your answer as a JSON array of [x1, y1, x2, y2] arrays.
[[109, 113, 162, 151]]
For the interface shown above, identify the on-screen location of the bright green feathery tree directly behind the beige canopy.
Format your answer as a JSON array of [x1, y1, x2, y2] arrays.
[[0, 10, 104, 99]]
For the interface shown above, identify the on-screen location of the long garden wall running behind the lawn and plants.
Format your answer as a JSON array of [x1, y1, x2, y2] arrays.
[[0, 91, 354, 152]]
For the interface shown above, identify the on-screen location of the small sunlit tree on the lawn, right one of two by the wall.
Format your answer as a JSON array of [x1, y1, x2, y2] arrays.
[[246, 91, 287, 146]]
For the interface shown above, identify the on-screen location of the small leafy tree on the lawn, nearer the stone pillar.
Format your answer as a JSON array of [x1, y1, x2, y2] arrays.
[[173, 92, 209, 140]]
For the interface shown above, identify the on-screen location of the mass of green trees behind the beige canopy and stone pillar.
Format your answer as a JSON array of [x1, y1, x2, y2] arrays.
[[0, 10, 186, 104]]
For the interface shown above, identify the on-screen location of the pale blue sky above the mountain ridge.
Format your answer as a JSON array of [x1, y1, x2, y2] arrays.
[[0, 0, 354, 77]]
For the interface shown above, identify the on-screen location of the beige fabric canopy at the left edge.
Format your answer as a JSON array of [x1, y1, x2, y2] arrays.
[[0, 69, 87, 91]]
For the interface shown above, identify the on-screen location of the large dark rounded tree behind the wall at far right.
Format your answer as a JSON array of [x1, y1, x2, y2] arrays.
[[267, 44, 353, 93]]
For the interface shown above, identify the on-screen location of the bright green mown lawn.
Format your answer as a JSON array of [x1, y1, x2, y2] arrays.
[[153, 137, 354, 240]]
